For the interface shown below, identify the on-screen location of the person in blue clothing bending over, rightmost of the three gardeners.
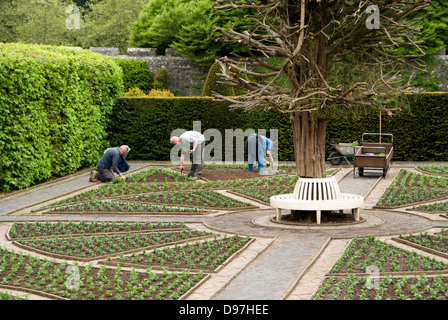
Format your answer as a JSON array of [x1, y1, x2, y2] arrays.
[[244, 134, 273, 173]]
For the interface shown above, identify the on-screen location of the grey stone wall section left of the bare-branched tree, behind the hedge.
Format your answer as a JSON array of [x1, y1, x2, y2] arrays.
[[90, 47, 209, 96]]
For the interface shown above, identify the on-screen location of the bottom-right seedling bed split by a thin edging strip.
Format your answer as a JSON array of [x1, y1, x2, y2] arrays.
[[314, 235, 448, 300]]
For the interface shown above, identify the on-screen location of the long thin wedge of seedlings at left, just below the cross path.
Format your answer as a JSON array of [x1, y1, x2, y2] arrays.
[[8, 220, 182, 239]]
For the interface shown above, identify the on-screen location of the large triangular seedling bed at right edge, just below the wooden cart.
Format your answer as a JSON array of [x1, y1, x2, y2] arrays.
[[377, 169, 448, 207]]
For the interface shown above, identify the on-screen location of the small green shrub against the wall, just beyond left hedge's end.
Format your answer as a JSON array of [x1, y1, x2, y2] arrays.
[[114, 58, 152, 93]]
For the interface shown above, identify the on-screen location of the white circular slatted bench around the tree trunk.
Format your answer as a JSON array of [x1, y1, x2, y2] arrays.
[[270, 177, 364, 224]]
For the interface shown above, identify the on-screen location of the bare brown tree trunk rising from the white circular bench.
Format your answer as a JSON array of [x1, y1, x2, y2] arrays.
[[291, 111, 327, 178]]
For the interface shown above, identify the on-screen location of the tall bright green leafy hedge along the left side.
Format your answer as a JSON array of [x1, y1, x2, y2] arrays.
[[0, 43, 123, 191]]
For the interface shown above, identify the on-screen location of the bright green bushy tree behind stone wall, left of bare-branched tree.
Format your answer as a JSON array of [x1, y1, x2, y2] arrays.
[[130, 0, 250, 65]]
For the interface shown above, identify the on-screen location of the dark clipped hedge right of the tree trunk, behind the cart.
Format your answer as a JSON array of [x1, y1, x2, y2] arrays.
[[327, 93, 448, 161]]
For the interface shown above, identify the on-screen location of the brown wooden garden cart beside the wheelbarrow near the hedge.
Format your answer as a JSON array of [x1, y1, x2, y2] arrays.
[[353, 133, 394, 177]]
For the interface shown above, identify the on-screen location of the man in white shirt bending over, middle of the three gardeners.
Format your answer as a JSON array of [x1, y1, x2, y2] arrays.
[[170, 131, 205, 179]]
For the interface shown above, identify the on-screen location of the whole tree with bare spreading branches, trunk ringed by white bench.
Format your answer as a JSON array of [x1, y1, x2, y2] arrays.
[[214, 0, 429, 178]]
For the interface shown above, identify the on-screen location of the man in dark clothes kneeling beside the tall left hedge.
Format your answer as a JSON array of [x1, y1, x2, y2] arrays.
[[90, 145, 131, 182]]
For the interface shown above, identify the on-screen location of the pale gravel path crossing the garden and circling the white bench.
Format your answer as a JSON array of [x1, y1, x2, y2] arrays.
[[0, 162, 448, 300]]
